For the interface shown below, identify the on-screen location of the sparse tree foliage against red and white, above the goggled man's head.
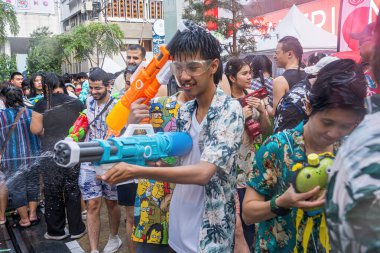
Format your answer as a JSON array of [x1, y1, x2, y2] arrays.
[[183, 0, 269, 55]]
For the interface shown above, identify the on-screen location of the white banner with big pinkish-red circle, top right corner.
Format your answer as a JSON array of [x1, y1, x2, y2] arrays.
[[338, 0, 380, 52]]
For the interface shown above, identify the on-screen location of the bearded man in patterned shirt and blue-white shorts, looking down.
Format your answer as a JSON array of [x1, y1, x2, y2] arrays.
[[79, 68, 122, 253]]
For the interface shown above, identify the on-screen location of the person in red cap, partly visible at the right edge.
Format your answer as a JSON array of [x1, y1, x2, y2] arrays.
[[350, 22, 380, 96]]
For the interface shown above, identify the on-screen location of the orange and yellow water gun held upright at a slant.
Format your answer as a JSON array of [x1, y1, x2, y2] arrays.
[[106, 21, 194, 136]]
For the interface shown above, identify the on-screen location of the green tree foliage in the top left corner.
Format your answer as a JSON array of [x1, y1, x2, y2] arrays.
[[0, 1, 20, 45]]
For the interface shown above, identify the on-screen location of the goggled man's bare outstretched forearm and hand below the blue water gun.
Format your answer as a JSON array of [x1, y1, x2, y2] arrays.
[[101, 161, 217, 185]]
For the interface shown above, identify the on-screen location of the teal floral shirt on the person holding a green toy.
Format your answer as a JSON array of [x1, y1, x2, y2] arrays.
[[247, 122, 337, 253]]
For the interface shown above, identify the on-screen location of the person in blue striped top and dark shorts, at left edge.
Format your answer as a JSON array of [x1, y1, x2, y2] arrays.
[[0, 86, 40, 228]]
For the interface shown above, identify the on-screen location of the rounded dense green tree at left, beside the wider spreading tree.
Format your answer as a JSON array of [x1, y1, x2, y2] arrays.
[[27, 27, 63, 74]]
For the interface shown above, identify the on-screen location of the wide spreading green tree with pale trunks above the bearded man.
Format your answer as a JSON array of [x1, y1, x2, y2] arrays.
[[59, 22, 124, 67]]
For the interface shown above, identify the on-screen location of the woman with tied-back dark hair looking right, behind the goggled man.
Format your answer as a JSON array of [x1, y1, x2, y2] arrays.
[[225, 58, 270, 252]]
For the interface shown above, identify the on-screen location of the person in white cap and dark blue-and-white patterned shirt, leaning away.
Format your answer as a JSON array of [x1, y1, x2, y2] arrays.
[[273, 56, 339, 133]]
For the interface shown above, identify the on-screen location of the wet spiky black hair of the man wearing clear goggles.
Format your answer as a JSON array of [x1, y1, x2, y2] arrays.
[[168, 21, 223, 84]]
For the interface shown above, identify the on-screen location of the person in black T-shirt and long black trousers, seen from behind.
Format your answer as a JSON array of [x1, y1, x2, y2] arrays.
[[31, 73, 86, 240]]
